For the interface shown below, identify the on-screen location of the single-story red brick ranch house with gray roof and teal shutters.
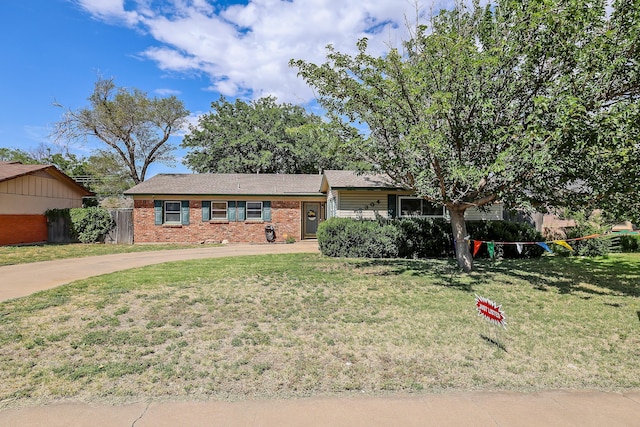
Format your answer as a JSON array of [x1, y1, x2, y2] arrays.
[[125, 171, 503, 243]]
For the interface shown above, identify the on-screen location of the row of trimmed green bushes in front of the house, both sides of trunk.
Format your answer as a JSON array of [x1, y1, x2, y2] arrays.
[[317, 218, 544, 258]]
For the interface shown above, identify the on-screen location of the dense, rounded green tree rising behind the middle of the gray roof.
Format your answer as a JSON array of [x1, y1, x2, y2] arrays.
[[182, 97, 356, 173]]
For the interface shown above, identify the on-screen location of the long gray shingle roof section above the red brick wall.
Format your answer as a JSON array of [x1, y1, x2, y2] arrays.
[[124, 173, 322, 196]]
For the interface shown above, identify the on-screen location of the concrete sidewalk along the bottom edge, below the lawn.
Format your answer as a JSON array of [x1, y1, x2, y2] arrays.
[[0, 391, 640, 427]]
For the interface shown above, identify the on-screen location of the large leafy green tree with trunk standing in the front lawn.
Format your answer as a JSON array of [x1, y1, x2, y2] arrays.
[[291, 0, 640, 271]]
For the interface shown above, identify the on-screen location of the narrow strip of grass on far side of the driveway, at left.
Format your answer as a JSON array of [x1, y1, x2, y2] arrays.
[[0, 243, 208, 266]]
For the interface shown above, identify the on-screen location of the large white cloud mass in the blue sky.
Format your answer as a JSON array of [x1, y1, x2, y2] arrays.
[[77, 0, 456, 103]]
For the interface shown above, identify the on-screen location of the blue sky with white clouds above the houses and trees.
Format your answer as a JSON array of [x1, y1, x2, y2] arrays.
[[0, 0, 447, 178]]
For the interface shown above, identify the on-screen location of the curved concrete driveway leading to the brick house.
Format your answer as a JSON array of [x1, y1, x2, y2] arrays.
[[0, 240, 318, 301]]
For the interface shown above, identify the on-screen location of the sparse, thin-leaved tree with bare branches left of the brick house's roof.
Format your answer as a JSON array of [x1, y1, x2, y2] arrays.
[[53, 78, 189, 184]]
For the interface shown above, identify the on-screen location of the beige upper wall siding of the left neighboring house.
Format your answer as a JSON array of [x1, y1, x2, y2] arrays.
[[0, 175, 82, 215]]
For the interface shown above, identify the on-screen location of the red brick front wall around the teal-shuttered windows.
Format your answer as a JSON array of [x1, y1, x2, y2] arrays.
[[133, 200, 301, 243]]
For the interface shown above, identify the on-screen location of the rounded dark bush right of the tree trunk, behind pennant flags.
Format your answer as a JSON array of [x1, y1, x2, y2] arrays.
[[467, 221, 544, 258]]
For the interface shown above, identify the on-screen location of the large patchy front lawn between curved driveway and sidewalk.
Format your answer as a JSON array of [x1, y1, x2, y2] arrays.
[[0, 254, 640, 406]]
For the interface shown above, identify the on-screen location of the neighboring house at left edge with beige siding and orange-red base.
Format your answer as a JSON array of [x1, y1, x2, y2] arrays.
[[0, 162, 93, 245]]
